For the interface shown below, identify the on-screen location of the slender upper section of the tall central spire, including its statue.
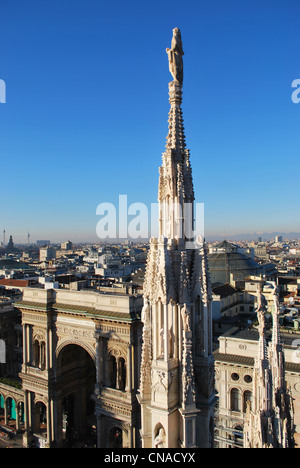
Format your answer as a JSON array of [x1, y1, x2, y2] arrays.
[[158, 28, 194, 239]]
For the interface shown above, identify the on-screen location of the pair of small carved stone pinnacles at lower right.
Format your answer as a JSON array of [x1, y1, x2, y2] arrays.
[[244, 285, 294, 448]]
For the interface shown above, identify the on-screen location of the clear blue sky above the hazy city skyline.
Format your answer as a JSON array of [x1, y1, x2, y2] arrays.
[[0, 0, 300, 242]]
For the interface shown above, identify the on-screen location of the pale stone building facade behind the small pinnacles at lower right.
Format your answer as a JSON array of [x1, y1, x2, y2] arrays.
[[214, 284, 300, 448]]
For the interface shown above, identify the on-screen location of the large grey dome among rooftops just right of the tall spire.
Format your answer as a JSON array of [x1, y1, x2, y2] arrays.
[[208, 241, 260, 284]]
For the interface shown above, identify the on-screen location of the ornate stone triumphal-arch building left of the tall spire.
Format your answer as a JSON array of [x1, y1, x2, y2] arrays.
[[15, 288, 142, 448]]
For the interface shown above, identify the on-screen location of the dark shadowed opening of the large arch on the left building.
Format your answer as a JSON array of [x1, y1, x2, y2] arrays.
[[58, 344, 96, 447]]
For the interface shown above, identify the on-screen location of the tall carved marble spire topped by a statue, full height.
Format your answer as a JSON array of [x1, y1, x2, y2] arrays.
[[139, 28, 215, 448]]
